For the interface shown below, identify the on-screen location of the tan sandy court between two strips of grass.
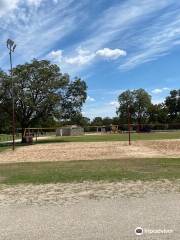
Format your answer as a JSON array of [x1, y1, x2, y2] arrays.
[[0, 140, 180, 163]]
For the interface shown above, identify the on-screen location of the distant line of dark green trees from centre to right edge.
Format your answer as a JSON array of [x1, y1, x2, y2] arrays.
[[61, 89, 180, 130]]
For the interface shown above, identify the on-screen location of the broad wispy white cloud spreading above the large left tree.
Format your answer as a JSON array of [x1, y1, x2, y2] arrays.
[[0, 0, 84, 68]]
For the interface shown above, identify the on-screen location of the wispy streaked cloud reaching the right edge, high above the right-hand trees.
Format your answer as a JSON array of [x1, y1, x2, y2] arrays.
[[120, 0, 180, 70]]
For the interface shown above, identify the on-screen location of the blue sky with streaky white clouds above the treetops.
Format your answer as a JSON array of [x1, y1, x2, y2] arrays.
[[0, 0, 180, 118]]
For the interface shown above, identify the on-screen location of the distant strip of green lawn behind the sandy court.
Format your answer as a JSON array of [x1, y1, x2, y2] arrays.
[[37, 131, 180, 143]]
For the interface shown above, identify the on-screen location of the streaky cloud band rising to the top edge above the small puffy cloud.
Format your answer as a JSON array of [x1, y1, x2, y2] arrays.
[[77, 0, 174, 50]]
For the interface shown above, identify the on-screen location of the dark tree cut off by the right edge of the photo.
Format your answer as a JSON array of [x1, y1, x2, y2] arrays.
[[165, 89, 180, 122]]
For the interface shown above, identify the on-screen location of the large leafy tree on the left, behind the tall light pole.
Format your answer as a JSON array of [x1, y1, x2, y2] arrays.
[[0, 60, 86, 141]]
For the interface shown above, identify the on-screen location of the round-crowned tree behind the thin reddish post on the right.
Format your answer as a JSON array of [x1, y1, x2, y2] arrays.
[[117, 88, 151, 130]]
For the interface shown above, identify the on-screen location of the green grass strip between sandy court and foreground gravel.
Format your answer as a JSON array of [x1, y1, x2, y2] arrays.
[[0, 158, 180, 184]]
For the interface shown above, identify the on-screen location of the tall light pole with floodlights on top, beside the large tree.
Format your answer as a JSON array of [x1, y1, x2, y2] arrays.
[[7, 39, 16, 151]]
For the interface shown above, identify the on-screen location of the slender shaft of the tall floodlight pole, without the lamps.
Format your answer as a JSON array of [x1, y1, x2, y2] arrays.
[[9, 47, 16, 151]]
